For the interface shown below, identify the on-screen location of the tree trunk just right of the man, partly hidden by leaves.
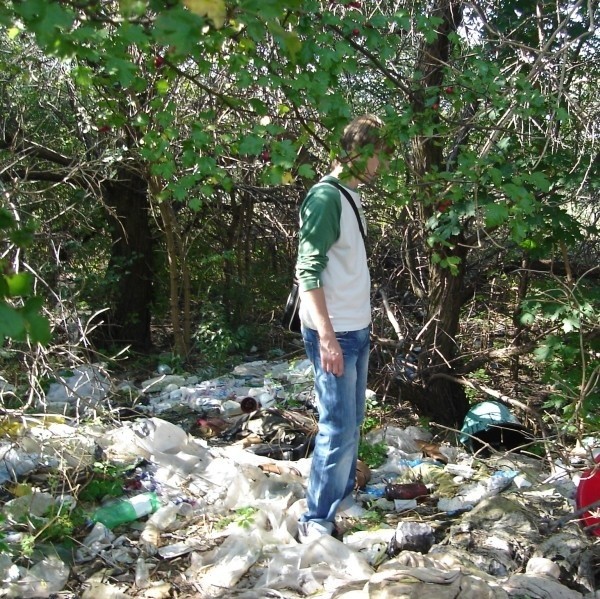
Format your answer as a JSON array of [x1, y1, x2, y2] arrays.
[[402, 0, 468, 426]]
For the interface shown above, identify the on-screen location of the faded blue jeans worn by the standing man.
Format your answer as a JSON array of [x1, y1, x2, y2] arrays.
[[300, 327, 370, 532]]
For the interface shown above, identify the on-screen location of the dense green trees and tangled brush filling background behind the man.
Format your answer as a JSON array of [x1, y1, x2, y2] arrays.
[[0, 0, 600, 432]]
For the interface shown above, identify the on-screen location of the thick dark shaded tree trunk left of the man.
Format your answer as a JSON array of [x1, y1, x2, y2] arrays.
[[99, 169, 154, 351]]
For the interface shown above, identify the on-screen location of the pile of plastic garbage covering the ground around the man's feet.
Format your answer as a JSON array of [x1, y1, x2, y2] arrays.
[[0, 361, 600, 599]]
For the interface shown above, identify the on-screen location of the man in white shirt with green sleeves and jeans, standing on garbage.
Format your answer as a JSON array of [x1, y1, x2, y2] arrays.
[[296, 115, 388, 543]]
